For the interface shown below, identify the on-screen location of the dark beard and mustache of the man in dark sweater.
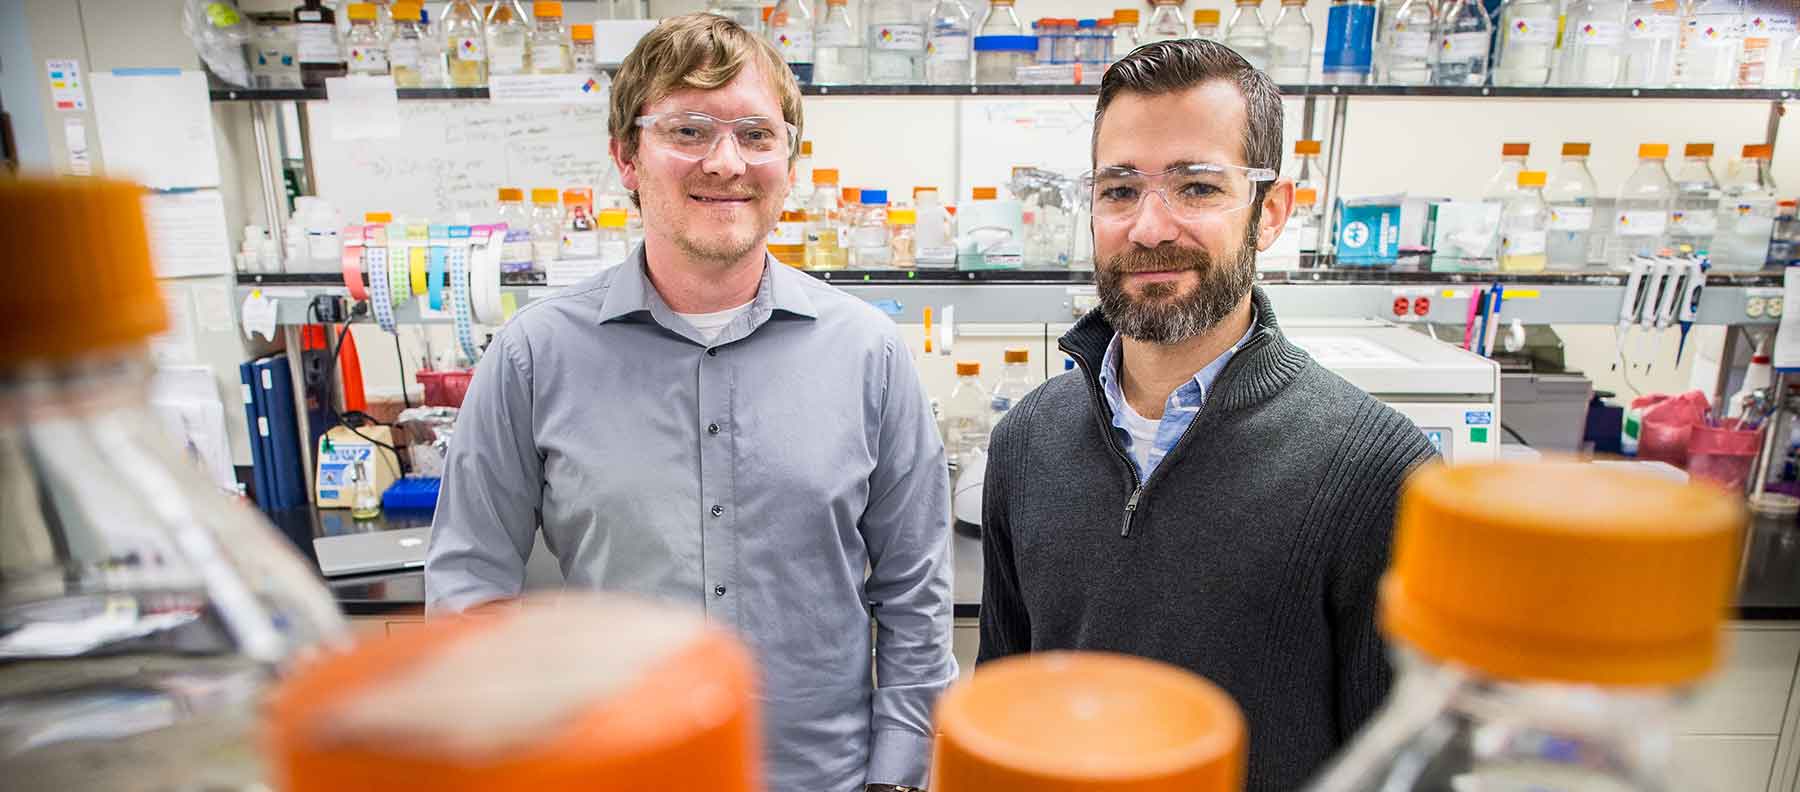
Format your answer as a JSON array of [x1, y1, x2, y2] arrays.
[[1094, 221, 1256, 344]]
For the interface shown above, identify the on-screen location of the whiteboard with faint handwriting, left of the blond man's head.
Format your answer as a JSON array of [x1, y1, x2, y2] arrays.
[[308, 101, 612, 223]]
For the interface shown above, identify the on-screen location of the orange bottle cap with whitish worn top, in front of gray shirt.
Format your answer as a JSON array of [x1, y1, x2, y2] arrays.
[[265, 596, 761, 792]]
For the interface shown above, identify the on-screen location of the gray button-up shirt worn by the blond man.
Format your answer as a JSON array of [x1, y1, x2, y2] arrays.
[[425, 248, 956, 792]]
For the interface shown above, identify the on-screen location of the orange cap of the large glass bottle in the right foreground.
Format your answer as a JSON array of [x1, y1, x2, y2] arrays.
[[1381, 463, 1744, 686]]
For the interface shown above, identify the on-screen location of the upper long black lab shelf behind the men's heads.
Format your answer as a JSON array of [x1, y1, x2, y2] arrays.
[[211, 85, 1800, 103]]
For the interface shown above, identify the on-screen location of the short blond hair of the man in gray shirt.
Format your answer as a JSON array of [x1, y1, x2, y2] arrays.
[[607, 13, 806, 162]]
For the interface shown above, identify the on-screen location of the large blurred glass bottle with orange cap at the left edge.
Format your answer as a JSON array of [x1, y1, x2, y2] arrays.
[[0, 178, 347, 790]]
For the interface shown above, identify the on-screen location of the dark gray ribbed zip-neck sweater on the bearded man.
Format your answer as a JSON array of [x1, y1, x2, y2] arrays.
[[981, 288, 1435, 792]]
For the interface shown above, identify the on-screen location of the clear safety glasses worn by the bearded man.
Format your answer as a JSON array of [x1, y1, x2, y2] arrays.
[[1080, 162, 1276, 221]]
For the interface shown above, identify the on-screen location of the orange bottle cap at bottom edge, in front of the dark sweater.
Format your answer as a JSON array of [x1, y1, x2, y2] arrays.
[[931, 652, 1246, 792]]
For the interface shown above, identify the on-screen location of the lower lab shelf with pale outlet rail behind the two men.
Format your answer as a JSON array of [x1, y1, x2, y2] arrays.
[[238, 268, 1782, 324]]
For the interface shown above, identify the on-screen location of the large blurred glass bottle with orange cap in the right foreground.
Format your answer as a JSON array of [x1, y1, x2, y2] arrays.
[[1305, 463, 1744, 792]]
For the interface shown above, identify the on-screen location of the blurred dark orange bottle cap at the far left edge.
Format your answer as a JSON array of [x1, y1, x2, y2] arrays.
[[0, 178, 169, 365]]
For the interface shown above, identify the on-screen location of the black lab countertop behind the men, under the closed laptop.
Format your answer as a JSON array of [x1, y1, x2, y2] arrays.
[[275, 509, 1800, 621]]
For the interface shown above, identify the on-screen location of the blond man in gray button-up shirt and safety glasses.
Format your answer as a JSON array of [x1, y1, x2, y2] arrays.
[[425, 14, 956, 792]]
